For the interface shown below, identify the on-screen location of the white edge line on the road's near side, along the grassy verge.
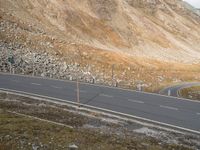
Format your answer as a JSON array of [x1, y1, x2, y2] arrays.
[[0, 88, 200, 134]]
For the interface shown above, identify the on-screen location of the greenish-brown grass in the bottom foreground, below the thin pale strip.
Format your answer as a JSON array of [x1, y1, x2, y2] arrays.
[[0, 112, 192, 150]]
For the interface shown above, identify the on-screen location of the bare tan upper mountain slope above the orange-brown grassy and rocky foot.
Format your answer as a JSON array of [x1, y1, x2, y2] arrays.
[[1, 0, 200, 62]]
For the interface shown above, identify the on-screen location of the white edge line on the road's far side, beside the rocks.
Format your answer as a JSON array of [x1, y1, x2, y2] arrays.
[[0, 72, 200, 103]]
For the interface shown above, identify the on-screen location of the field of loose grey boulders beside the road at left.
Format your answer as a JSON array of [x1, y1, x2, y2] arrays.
[[0, 41, 95, 83]]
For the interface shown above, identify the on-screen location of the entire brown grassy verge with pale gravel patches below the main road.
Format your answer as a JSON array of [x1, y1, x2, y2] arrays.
[[0, 93, 195, 150]]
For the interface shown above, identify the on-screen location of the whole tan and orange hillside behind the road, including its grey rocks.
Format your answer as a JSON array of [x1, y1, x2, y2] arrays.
[[0, 0, 200, 91]]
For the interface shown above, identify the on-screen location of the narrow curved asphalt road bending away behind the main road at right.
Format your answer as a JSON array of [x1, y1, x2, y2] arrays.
[[159, 82, 200, 97]]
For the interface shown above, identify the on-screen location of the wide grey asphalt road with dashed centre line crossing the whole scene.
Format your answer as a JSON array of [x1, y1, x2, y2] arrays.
[[0, 74, 200, 133]]
